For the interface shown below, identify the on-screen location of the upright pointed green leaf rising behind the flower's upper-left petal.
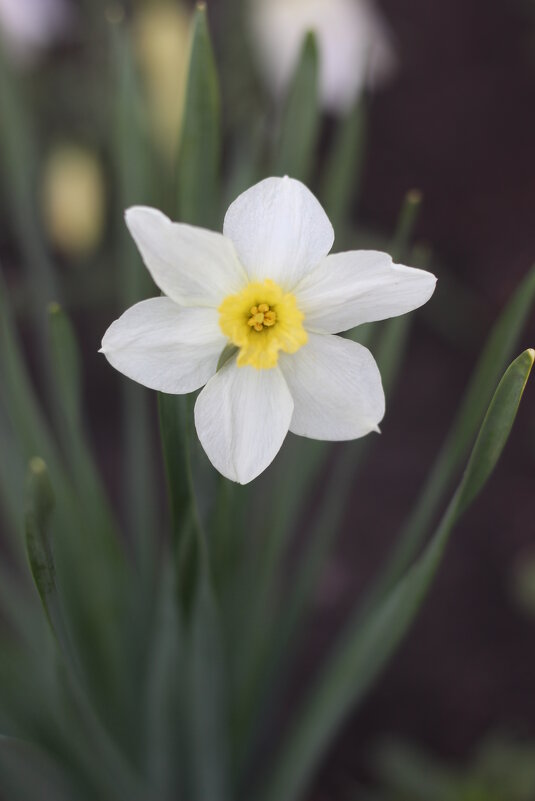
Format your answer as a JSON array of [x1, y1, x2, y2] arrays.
[[178, 3, 221, 228]]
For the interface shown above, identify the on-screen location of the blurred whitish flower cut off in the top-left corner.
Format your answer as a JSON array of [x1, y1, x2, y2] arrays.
[[0, 0, 72, 63]]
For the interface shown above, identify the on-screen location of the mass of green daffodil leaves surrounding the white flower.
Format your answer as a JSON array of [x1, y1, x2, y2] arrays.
[[0, 2, 535, 801]]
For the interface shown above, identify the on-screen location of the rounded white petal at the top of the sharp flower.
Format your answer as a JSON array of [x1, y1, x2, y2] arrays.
[[223, 176, 334, 290]]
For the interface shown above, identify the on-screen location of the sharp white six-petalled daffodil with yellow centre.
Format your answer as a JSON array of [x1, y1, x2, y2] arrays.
[[102, 177, 436, 484]]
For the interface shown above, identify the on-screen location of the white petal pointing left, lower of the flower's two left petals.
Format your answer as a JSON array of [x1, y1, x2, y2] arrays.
[[102, 298, 226, 395]]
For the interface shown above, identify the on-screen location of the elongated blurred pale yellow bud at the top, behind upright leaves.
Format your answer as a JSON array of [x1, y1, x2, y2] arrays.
[[134, 0, 192, 159]]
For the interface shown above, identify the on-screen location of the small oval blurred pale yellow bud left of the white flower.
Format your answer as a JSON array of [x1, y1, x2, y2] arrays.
[[42, 145, 105, 256]]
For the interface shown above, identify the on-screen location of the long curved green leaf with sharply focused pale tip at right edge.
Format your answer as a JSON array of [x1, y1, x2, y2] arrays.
[[260, 350, 535, 801]]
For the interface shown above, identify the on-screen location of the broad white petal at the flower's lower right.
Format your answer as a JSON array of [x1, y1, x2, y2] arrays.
[[279, 334, 385, 441]]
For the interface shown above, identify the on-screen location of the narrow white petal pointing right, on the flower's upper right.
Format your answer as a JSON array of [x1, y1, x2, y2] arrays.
[[295, 250, 437, 333]]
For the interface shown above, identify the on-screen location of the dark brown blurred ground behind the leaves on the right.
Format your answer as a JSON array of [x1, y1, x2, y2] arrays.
[[310, 0, 535, 801]]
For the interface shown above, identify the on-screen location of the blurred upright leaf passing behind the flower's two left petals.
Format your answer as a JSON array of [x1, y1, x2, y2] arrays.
[[108, 12, 158, 568]]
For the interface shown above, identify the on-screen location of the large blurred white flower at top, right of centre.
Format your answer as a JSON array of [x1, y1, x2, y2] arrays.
[[250, 0, 395, 113]]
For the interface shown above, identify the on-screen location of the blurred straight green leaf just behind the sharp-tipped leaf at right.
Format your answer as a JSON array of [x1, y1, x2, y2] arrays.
[[370, 267, 535, 602]]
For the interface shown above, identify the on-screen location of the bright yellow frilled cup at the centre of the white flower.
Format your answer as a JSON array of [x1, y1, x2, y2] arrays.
[[219, 279, 308, 370]]
